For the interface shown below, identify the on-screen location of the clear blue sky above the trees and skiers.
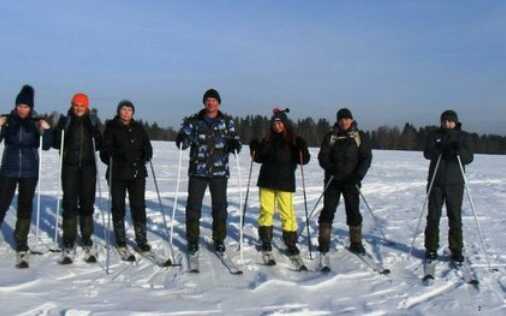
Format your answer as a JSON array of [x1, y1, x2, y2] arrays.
[[0, 0, 506, 134]]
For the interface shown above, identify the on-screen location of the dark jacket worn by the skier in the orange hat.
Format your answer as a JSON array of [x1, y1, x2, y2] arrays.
[[53, 111, 102, 167]]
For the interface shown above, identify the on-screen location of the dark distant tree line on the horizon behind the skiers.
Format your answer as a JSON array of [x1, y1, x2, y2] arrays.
[[87, 110, 506, 155]]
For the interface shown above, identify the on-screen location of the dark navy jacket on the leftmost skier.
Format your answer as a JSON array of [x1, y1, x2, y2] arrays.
[[0, 111, 52, 178]]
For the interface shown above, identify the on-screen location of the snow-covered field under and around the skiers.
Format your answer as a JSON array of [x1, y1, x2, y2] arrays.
[[0, 142, 506, 315]]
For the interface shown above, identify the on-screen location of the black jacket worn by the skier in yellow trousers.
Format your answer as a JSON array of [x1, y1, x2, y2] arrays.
[[254, 134, 310, 192]]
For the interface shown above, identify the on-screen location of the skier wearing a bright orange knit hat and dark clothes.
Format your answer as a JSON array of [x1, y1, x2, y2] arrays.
[[53, 93, 102, 264]]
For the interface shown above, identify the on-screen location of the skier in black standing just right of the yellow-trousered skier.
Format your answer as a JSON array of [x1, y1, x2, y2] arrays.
[[318, 108, 372, 255]]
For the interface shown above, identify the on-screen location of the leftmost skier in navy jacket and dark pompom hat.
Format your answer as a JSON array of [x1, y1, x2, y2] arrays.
[[0, 85, 52, 268]]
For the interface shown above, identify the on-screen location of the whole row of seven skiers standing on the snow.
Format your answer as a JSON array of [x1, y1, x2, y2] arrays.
[[0, 86, 473, 278]]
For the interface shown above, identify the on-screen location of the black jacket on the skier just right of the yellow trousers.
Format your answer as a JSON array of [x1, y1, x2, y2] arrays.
[[318, 122, 372, 184]]
